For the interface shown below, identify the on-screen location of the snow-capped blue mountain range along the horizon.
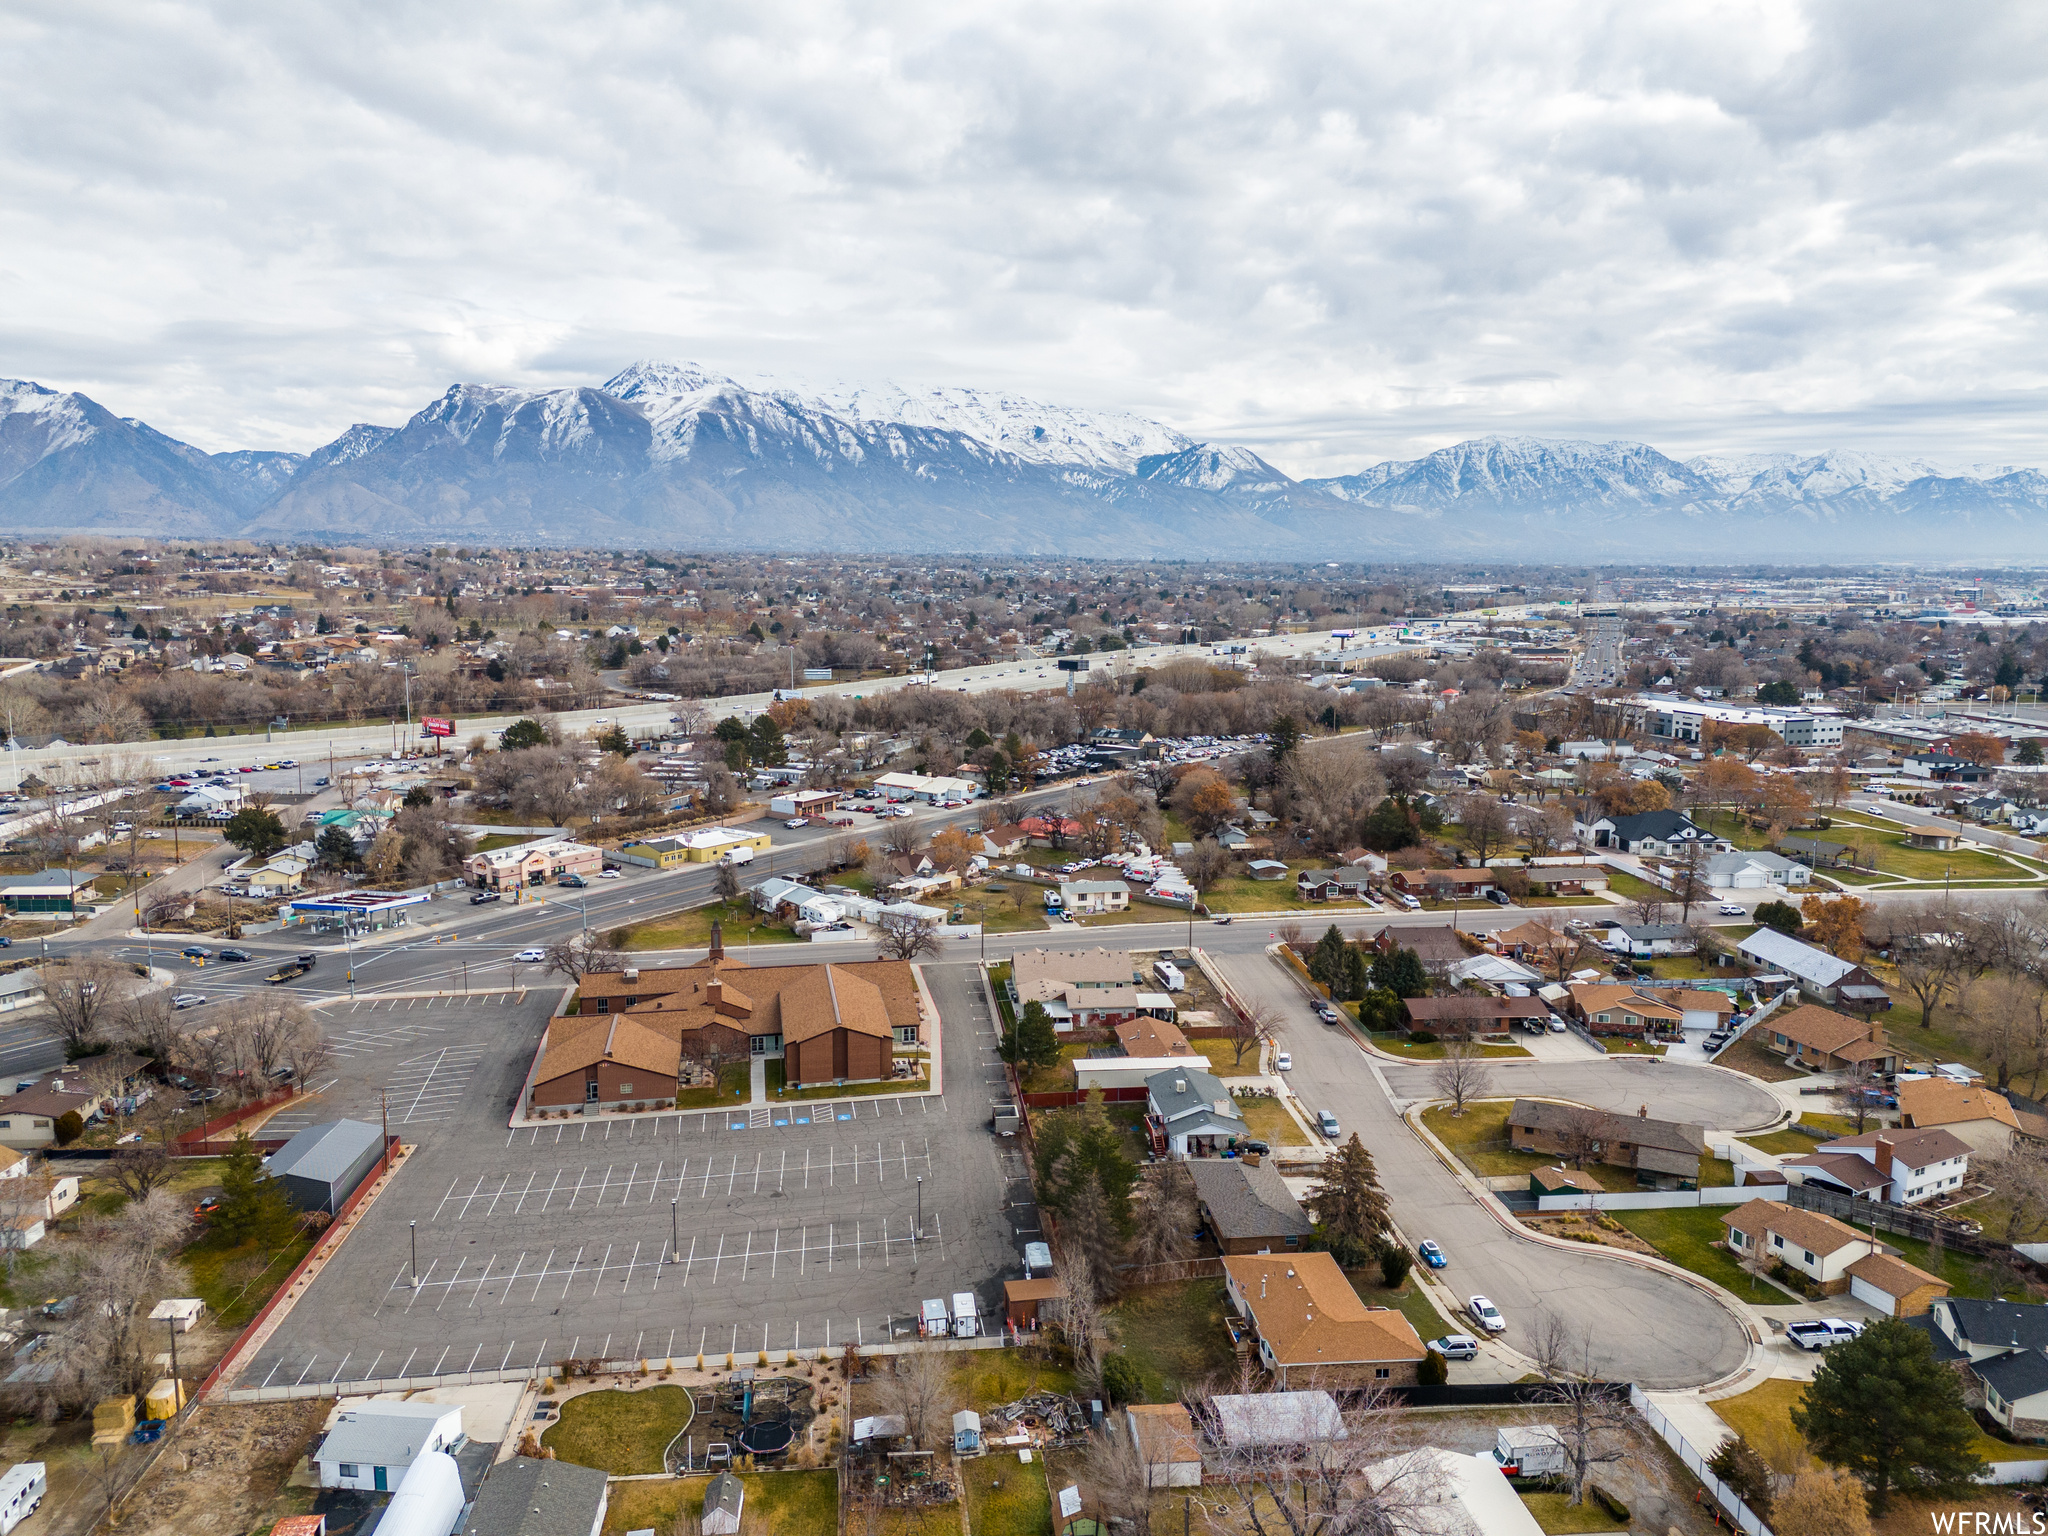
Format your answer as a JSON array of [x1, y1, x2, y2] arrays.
[[0, 362, 2048, 563]]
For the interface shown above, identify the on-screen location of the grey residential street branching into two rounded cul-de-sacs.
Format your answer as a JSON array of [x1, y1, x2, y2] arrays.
[[1219, 954, 1776, 1389]]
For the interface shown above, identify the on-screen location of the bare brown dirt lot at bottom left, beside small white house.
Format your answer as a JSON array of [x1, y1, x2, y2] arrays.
[[121, 1399, 334, 1536]]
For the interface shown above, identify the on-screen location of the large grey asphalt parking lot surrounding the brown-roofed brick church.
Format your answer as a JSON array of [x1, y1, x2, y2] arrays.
[[240, 965, 1038, 1386]]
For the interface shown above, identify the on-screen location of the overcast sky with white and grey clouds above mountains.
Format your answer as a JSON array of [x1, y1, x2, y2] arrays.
[[0, 0, 2048, 473]]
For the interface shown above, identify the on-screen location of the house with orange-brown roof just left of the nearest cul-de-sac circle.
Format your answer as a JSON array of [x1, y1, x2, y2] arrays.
[[1223, 1253, 1423, 1391]]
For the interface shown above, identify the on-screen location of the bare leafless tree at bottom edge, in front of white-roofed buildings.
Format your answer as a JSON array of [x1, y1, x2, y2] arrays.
[[1192, 1382, 1442, 1536]]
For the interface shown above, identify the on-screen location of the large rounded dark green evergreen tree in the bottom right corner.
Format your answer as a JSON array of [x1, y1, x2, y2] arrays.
[[1792, 1317, 1985, 1516]]
